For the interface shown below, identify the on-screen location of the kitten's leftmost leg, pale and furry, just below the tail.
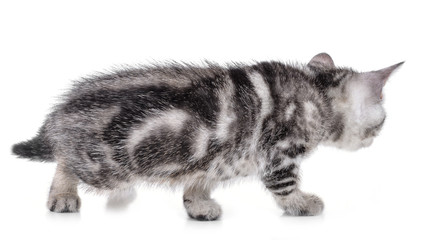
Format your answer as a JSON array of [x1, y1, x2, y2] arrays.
[[47, 163, 81, 213]]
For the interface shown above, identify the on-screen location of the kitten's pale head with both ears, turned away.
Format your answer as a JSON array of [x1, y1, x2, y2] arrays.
[[309, 53, 403, 150]]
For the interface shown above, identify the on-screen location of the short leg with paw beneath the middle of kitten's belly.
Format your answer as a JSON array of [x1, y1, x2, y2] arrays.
[[183, 181, 221, 221]]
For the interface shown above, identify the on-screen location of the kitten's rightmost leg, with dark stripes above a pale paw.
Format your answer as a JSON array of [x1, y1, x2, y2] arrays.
[[263, 163, 324, 216]]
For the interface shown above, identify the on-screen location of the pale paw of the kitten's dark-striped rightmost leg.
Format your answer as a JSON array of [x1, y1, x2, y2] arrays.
[[283, 194, 324, 216]]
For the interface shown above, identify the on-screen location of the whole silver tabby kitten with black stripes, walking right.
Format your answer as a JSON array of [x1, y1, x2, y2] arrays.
[[12, 53, 403, 220]]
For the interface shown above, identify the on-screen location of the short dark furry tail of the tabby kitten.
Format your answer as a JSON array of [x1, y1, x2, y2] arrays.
[[12, 134, 54, 162]]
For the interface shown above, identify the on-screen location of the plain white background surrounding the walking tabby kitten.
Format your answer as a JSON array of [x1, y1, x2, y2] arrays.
[[0, 0, 422, 240]]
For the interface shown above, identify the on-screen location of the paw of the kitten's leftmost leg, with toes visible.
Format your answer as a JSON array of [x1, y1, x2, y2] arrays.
[[47, 193, 81, 213]]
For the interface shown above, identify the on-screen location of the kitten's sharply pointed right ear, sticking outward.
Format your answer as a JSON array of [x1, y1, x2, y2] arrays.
[[362, 62, 404, 99]]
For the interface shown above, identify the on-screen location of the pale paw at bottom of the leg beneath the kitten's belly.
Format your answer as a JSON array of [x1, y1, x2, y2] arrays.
[[183, 199, 221, 221]]
